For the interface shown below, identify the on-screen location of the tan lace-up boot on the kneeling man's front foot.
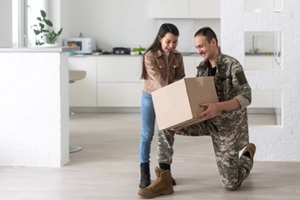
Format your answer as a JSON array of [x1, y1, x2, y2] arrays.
[[138, 167, 174, 199]]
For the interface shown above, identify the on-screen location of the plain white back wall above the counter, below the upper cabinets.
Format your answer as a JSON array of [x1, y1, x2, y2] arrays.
[[62, 0, 220, 51]]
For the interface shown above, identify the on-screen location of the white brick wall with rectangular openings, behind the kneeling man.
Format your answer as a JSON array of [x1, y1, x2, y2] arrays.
[[221, 0, 300, 161]]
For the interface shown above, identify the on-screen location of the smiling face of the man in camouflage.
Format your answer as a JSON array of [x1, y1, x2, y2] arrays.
[[195, 35, 215, 60]]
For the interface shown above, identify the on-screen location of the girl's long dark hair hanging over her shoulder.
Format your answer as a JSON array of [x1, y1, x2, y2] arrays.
[[141, 23, 179, 79]]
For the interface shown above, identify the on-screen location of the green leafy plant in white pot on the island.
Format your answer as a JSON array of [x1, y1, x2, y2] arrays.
[[31, 10, 63, 46]]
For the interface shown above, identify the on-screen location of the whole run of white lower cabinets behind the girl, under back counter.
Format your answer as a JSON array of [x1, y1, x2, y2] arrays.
[[69, 55, 202, 107]]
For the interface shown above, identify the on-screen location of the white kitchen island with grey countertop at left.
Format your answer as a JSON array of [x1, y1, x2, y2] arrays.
[[0, 47, 76, 167]]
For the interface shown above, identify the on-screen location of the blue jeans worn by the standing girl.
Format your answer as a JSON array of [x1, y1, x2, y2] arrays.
[[140, 91, 155, 163]]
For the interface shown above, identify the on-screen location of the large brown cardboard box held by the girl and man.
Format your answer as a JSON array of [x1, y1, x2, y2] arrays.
[[151, 77, 218, 130]]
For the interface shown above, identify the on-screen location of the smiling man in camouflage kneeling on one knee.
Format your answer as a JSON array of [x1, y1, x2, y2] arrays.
[[139, 27, 256, 198]]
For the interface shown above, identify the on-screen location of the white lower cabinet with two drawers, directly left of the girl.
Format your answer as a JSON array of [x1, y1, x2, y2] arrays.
[[97, 56, 142, 107]]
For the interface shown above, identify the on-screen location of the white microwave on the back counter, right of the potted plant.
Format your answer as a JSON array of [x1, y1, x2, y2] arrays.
[[63, 38, 96, 54]]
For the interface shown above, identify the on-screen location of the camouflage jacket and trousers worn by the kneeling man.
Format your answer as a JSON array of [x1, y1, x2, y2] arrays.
[[158, 53, 253, 190]]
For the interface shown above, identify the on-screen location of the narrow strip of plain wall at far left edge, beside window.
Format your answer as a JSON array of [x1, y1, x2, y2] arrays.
[[0, 0, 12, 47]]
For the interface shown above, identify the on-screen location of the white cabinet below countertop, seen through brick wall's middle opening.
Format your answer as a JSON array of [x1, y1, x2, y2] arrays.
[[244, 56, 274, 70]]
